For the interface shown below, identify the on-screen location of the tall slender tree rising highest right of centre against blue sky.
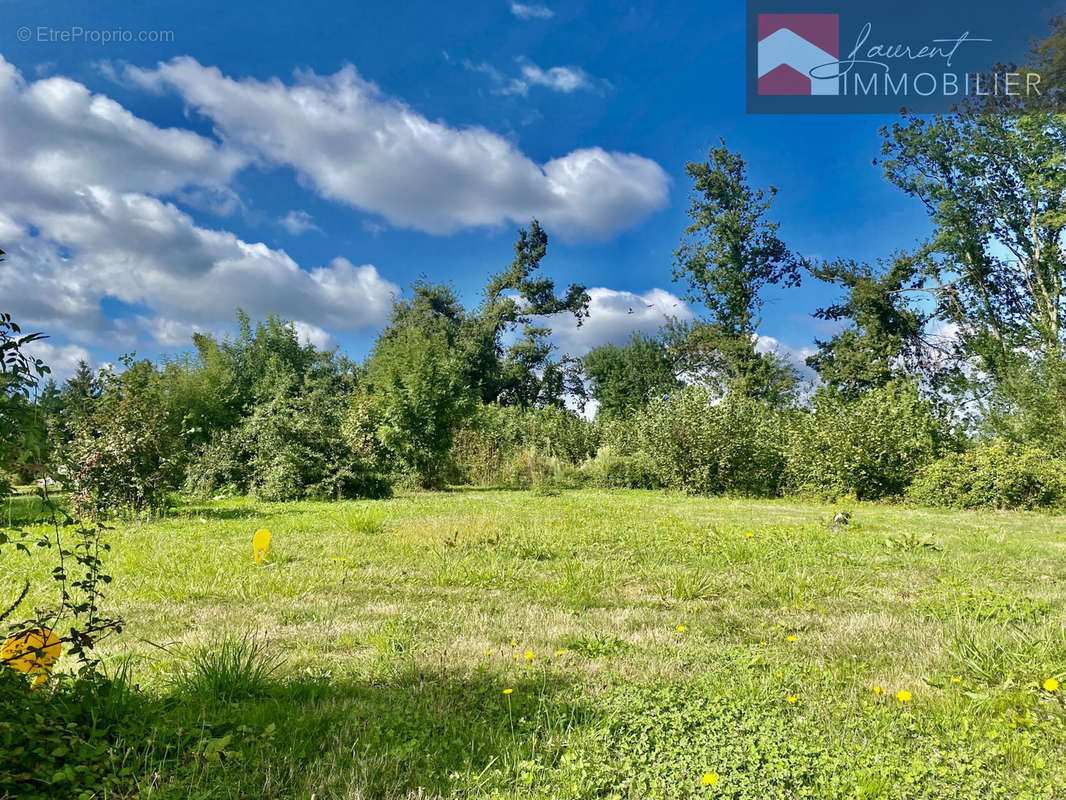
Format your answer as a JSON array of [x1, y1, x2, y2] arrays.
[[669, 142, 804, 397]]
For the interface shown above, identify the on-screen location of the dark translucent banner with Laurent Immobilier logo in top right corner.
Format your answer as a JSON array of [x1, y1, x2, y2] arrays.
[[746, 0, 1066, 114]]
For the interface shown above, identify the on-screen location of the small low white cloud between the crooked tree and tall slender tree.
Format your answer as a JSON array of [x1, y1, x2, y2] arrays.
[[547, 287, 693, 356]]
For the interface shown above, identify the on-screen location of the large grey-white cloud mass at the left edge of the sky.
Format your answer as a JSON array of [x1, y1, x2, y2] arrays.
[[0, 59, 398, 348]]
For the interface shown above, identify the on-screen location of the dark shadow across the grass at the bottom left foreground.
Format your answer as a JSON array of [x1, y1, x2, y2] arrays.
[[0, 667, 594, 800]]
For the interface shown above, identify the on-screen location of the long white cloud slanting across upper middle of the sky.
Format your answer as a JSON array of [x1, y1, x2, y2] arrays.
[[127, 58, 668, 238]]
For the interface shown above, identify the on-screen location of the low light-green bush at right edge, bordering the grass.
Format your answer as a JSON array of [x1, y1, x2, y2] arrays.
[[907, 439, 1066, 509]]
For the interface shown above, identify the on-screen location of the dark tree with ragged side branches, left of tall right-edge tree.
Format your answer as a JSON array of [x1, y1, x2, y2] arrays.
[[807, 256, 932, 394]]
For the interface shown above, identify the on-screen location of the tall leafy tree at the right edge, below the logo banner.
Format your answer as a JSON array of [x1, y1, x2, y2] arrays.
[[882, 113, 1066, 443]]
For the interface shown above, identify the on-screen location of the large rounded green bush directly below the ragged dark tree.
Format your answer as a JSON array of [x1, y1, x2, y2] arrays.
[[787, 383, 949, 500]]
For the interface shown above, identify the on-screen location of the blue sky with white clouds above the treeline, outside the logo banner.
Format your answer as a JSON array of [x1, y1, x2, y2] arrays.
[[0, 0, 1055, 378]]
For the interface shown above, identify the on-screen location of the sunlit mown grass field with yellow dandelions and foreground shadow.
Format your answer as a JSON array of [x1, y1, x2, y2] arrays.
[[6, 491, 1066, 800]]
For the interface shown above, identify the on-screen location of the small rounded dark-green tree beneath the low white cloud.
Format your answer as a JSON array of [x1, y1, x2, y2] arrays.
[[584, 333, 680, 417]]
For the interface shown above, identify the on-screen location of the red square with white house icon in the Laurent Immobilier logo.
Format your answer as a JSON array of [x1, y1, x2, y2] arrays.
[[758, 14, 840, 95]]
